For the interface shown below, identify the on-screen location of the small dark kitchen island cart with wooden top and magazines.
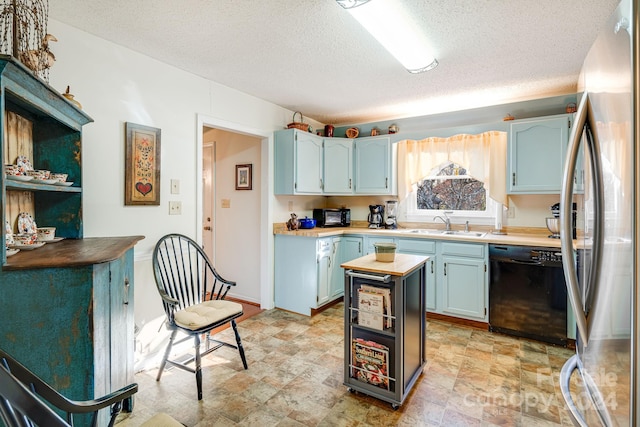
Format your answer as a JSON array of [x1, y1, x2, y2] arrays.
[[341, 254, 429, 409]]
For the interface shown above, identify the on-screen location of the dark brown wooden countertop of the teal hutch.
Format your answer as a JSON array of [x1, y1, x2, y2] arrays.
[[2, 236, 144, 270]]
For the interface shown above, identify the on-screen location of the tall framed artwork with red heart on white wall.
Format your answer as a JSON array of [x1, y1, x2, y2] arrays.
[[124, 122, 161, 206]]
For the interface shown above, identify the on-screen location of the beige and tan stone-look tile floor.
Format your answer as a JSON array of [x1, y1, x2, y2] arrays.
[[117, 303, 573, 427]]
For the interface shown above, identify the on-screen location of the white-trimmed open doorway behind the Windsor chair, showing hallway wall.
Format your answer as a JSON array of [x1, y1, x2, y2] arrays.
[[196, 117, 273, 308]]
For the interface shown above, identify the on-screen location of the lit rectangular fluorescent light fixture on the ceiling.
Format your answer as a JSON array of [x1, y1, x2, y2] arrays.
[[336, 0, 438, 73]]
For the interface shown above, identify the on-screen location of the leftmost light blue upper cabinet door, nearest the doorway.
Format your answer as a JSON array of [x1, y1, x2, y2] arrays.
[[294, 132, 322, 194]]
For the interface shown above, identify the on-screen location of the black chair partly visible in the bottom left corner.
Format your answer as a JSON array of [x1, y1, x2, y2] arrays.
[[0, 350, 138, 427]]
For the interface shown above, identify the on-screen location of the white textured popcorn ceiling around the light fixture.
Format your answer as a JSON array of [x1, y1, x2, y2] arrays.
[[49, 0, 618, 124]]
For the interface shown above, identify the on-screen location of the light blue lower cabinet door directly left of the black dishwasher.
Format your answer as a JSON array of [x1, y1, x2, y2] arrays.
[[442, 255, 486, 320]]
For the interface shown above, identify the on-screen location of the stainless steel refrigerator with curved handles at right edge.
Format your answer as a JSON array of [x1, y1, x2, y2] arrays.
[[560, 0, 640, 426]]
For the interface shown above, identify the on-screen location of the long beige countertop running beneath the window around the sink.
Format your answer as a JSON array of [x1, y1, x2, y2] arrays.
[[273, 223, 564, 248]]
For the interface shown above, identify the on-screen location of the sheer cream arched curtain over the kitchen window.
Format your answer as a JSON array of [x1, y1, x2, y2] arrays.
[[398, 131, 508, 206]]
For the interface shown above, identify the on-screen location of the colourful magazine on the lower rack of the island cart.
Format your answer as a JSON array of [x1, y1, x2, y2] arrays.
[[351, 338, 390, 390]]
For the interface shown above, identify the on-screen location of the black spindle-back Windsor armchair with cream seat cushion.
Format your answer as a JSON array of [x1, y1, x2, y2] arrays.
[[153, 234, 247, 400]]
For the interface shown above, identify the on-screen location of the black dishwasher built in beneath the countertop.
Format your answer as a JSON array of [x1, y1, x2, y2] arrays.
[[489, 244, 567, 346]]
